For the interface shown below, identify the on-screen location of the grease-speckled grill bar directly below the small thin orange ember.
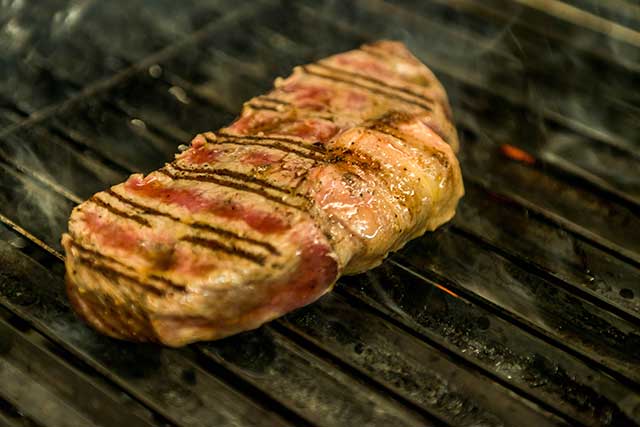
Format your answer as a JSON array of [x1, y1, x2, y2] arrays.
[[337, 268, 628, 425]]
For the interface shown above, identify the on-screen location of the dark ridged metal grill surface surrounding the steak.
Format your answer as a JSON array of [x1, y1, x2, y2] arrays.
[[0, 0, 640, 426]]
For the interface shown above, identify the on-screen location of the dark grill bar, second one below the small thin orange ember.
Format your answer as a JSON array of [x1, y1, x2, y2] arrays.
[[284, 294, 558, 426]]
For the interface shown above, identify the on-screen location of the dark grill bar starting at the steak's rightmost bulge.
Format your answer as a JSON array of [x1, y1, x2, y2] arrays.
[[454, 183, 640, 323]]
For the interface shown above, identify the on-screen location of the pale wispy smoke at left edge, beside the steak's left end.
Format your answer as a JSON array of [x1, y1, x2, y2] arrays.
[[0, 122, 124, 250]]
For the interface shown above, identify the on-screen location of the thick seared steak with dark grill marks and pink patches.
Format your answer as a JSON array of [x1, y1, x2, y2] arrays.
[[63, 41, 463, 346]]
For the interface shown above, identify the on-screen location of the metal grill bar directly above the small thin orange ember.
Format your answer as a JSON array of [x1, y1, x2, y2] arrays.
[[401, 234, 638, 383]]
